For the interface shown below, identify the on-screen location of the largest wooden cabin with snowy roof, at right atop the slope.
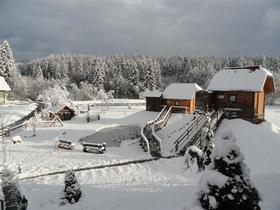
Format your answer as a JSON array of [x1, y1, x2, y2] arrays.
[[207, 66, 275, 120]]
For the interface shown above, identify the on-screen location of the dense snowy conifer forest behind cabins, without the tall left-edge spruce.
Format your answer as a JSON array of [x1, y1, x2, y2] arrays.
[[18, 54, 280, 100]]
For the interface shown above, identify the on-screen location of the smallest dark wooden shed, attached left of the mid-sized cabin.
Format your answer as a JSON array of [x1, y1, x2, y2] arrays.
[[143, 91, 162, 112]]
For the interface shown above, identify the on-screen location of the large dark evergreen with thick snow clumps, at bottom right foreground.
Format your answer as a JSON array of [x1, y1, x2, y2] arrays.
[[199, 133, 260, 210]]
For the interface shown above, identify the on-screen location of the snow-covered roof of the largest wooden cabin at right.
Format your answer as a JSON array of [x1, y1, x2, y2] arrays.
[[207, 67, 275, 92]]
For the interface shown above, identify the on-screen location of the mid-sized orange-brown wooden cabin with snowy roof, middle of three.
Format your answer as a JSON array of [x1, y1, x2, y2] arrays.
[[162, 83, 202, 113]]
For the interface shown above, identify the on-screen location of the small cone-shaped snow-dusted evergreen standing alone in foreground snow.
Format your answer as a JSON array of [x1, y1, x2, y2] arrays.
[[61, 170, 82, 205]]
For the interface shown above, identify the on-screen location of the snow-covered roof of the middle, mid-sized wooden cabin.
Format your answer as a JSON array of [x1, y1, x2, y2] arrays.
[[162, 83, 202, 100]]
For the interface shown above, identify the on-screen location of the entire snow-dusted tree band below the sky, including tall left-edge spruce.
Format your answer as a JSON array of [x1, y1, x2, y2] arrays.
[[0, 41, 280, 100]]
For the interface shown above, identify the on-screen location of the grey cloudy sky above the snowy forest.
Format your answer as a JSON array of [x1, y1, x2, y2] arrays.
[[0, 0, 280, 59]]
